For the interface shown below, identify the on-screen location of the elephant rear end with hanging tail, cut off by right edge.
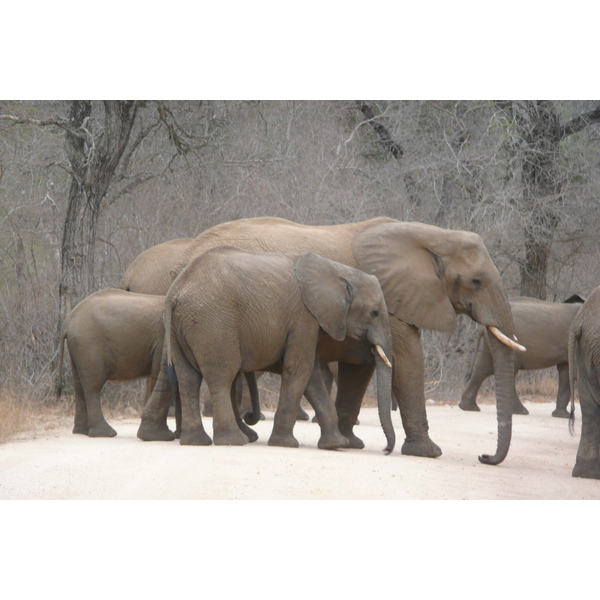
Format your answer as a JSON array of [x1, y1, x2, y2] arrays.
[[569, 286, 600, 479]]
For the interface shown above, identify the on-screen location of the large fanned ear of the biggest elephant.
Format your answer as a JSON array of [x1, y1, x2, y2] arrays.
[[352, 222, 456, 331]]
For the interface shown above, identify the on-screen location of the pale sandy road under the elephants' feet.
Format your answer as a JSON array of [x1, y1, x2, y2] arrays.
[[0, 401, 600, 500]]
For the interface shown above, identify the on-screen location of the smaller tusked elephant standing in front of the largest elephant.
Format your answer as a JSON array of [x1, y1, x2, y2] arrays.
[[138, 246, 395, 453]]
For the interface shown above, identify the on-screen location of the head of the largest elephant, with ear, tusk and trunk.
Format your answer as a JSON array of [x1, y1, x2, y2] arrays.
[[352, 222, 523, 464]]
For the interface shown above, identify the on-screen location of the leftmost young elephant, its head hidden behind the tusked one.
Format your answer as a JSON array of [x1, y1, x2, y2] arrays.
[[58, 289, 175, 437]]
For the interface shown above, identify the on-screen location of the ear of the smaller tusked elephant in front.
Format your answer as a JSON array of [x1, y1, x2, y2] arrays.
[[295, 252, 354, 342]]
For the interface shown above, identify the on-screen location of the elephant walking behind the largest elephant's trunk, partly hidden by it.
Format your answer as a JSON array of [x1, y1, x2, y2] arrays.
[[458, 294, 583, 418]]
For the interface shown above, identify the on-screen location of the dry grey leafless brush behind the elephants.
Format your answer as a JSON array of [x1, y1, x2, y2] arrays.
[[0, 101, 600, 439]]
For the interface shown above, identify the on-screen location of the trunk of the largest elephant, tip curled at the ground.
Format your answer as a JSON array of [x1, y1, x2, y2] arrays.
[[479, 327, 516, 465]]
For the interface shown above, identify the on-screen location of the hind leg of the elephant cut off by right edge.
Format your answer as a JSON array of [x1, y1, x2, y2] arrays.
[[571, 378, 600, 479]]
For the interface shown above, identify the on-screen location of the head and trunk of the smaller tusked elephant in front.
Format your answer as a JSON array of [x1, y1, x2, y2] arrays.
[[295, 252, 395, 453]]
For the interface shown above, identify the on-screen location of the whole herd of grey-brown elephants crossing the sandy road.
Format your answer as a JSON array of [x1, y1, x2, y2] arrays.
[[59, 217, 600, 478]]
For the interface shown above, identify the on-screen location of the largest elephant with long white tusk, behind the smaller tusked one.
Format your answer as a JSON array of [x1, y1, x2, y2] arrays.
[[123, 217, 523, 464]]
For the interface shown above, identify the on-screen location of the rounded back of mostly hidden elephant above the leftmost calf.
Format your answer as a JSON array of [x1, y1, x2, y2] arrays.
[[119, 238, 194, 296]]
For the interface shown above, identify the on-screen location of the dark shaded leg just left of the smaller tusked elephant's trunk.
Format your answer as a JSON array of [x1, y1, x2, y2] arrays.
[[335, 362, 375, 449]]
